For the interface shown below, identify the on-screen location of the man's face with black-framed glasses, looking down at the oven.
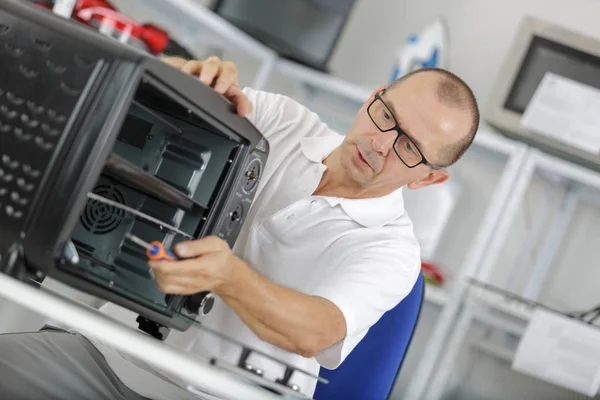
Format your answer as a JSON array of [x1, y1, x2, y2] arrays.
[[340, 73, 471, 193]]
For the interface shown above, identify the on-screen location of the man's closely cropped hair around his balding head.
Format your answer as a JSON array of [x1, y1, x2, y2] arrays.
[[388, 68, 480, 167]]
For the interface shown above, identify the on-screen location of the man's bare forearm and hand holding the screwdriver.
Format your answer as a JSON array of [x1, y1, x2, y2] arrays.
[[150, 237, 346, 357]]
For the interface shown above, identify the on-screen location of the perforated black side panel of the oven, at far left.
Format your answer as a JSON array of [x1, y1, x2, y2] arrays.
[[0, 11, 105, 241]]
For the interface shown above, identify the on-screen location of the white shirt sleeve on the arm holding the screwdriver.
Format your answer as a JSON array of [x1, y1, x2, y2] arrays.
[[311, 238, 421, 369]]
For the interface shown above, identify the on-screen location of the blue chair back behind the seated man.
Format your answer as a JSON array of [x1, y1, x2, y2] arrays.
[[314, 275, 425, 400]]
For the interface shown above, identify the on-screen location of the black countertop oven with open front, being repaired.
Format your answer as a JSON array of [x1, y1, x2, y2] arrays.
[[0, 0, 269, 336]]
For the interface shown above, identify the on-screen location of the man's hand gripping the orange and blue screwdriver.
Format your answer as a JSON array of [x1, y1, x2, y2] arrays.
[[149, 236, 237, 295]]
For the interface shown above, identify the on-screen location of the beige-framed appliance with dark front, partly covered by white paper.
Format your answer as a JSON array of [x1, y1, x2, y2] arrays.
[[485, 17, 600, 170]]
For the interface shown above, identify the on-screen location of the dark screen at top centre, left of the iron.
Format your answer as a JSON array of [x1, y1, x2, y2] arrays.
[[213, 0, 355, 70]]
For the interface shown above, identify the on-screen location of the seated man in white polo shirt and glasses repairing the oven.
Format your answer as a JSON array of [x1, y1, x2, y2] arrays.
[[0, 54, 479, 399]]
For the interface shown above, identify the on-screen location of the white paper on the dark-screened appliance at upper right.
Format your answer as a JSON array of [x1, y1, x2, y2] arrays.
[[521, 72, 600, 154]]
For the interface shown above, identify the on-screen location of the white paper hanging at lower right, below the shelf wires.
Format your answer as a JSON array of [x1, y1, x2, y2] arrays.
[[512, 310, 600, 397]]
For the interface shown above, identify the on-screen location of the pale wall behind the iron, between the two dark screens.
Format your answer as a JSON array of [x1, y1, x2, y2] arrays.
[[331, 0, 600, 114]]
